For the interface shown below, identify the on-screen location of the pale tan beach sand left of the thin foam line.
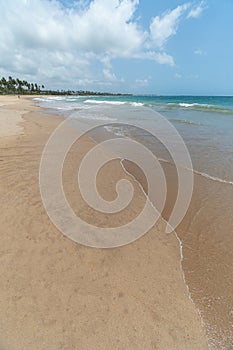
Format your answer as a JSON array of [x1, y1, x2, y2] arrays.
[[0, 97, 207, 350]]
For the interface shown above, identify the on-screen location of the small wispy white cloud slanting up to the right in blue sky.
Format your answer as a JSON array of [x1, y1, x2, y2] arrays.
[[150, 4, 190, 48]]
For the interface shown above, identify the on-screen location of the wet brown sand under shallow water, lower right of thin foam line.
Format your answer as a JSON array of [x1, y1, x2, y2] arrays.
[[125, 162, 233, 350]]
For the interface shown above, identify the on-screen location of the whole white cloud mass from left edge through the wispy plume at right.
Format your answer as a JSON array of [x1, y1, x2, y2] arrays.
[[0, 0, 204, 88]]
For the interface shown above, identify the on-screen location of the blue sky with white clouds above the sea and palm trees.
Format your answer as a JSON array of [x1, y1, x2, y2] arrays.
[[0, 0, 233, 95]]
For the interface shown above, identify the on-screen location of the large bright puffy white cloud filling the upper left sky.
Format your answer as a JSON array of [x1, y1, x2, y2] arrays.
[[0, 0, 144, 57]]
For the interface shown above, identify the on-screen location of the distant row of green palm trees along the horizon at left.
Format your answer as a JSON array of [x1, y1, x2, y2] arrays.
[[0, 76, 131, 96]]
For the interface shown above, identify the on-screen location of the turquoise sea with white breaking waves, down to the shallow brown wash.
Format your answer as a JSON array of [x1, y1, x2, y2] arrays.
[[37, 96, 233, 183]]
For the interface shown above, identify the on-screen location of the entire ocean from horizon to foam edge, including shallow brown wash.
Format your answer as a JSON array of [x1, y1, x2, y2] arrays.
[[35, 95, 233, 350]]
